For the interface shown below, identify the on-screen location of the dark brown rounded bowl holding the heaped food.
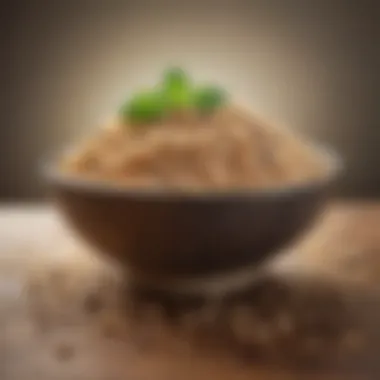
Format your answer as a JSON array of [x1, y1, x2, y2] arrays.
[[44, 149, 340, 276]]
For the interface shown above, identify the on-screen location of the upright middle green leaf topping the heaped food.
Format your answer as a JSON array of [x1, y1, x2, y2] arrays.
[[162, 68, 192, 111]]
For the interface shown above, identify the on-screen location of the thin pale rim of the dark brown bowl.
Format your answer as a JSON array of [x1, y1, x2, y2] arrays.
[[40, 143, 345, 201]]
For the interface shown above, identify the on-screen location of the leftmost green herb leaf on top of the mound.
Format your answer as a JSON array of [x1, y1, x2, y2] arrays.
[[120, 92, 165, 124]]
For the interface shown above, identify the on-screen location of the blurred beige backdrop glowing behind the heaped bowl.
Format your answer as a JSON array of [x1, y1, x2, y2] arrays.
[[0, 0, 380, 200]]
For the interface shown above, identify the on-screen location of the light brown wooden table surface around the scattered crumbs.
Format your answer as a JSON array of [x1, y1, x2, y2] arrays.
[[0, 202, 380, 380]]
